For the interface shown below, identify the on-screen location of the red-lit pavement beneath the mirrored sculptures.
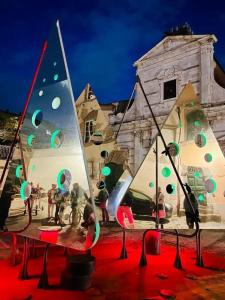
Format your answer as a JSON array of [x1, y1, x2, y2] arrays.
[[0, 228, 225, 300]]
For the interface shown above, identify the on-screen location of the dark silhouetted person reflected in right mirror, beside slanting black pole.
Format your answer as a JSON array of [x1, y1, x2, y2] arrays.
[[184, 184, 200, 229]]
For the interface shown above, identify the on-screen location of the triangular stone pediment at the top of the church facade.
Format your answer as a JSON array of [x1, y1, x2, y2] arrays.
[[134, 35, 217, 66]]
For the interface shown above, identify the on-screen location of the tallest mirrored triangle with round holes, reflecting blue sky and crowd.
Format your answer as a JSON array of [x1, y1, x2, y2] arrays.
[[1, 23, 99, 250]]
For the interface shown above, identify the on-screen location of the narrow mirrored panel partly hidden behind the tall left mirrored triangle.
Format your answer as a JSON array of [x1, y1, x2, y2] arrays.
[[76, 84, 132, 226]]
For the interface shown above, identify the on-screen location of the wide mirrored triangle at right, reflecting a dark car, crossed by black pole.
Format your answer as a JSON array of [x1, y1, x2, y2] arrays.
[[117, 84, 225, 229]]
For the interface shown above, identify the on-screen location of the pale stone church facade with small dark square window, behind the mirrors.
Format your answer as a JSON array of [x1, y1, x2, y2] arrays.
[[110, 34, 225, 172]]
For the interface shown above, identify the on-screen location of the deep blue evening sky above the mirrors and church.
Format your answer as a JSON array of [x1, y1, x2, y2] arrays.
[[0, 0, 225, 112]]
